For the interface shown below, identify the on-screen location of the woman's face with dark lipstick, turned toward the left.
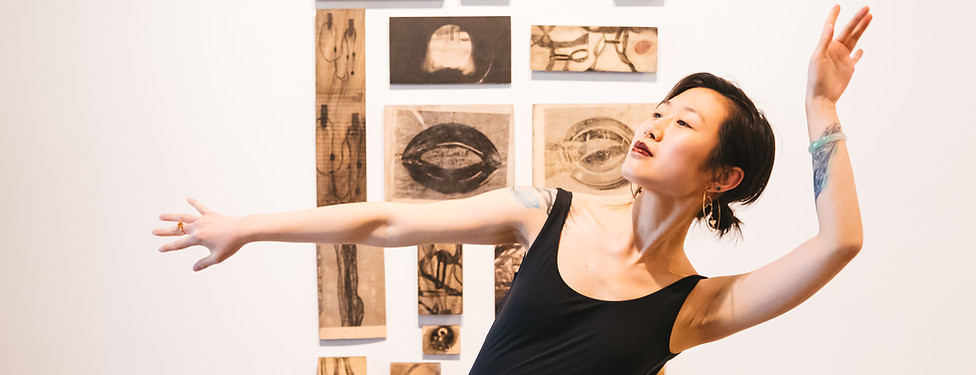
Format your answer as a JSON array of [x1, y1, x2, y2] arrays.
[[621, 87, 728, 197]]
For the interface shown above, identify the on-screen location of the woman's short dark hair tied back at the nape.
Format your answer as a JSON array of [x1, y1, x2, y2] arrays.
[[665, 73, 776, 237]]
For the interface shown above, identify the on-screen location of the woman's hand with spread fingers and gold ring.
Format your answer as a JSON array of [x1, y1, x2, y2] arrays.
[[152, 198, 246, 271]]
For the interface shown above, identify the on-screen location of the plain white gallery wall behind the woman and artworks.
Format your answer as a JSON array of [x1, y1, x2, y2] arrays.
[[0, 0, 976, 375]]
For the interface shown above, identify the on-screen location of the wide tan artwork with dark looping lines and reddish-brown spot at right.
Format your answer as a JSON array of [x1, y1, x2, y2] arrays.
[[529, 25, 657, 73]]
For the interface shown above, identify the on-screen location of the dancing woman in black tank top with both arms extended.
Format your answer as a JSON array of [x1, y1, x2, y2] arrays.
[[154, 6, 872, 374]]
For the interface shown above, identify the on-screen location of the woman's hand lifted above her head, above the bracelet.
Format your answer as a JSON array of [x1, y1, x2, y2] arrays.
[[807, 5, 873, 104]]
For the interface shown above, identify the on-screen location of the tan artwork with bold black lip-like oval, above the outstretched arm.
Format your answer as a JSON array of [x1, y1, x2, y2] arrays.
[[384, 105, 515, 201]]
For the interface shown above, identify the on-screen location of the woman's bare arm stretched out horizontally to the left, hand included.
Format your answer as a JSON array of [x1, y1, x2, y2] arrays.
[[153, 187, 555, 271]]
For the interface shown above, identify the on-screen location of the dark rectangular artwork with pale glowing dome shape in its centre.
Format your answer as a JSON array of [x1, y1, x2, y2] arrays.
[[390, 16, 512, 84]]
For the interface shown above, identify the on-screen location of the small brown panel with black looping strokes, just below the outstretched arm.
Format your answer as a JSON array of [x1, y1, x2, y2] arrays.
[[417, 244, 463, 315]]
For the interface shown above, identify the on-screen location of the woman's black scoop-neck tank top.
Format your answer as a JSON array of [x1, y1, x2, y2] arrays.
[[470, 189, 704, 375]]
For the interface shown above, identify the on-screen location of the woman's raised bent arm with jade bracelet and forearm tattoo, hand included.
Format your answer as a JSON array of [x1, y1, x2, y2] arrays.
[[673, 6, 872, 349]]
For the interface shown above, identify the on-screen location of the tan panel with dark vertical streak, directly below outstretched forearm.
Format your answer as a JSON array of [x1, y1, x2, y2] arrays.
[[316, 244, 386, 340]]
